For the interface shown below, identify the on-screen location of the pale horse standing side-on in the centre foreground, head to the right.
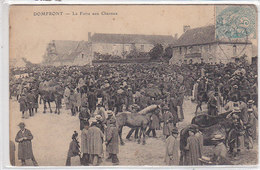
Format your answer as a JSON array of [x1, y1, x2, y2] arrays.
[[116, 105, 161, 145]]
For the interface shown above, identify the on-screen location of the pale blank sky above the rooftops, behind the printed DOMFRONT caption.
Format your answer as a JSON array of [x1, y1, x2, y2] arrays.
[[9, 5, 215, 63]]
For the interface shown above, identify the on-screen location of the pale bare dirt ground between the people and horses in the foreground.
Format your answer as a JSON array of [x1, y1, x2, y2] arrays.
[[10, 99, 258, 166]]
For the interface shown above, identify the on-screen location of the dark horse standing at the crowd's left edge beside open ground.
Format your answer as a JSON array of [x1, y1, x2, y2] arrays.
[[39, 85, 63, 114]]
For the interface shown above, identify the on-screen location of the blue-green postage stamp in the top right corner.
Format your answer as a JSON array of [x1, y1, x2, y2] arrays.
[[216, 5, 256, 39]]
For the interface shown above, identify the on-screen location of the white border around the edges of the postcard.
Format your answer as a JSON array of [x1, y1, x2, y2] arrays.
[[0, 0, 260, 170]]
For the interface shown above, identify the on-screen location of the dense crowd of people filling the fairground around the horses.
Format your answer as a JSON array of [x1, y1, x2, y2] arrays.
[[10, 60, 258, 165]]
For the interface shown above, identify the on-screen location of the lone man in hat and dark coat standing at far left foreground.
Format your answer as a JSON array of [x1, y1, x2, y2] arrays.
[[15, 122, 38, 166]]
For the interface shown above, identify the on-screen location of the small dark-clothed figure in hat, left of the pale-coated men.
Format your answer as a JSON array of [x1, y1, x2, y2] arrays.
[[66, 131, 80, 166]]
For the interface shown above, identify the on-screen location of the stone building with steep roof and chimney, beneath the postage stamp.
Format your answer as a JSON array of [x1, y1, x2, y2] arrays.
[[170, 25, 253, 64]]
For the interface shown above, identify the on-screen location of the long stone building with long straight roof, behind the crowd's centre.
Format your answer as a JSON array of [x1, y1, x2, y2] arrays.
[[88, 33, 174, 58]]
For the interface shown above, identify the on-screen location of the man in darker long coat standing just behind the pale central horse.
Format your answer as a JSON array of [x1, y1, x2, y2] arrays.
[[105, 119, 119, 165]]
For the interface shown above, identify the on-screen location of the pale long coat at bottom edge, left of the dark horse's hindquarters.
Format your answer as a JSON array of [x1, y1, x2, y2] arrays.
[[165, 135, 180, 165]]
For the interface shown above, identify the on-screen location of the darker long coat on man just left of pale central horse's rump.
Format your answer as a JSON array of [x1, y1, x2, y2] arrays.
[[106, 125, 119, 154]]
